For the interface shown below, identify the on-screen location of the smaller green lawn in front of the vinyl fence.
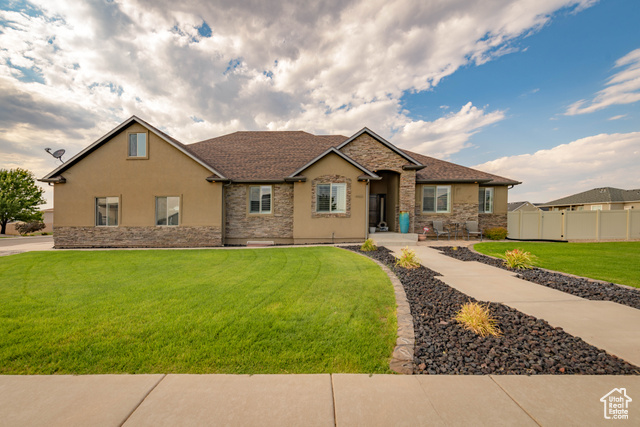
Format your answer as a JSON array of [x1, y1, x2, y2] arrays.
[[474, 242, 640, 288]]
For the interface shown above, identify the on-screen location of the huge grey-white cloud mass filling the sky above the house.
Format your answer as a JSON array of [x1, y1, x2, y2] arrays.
[[0, 0, 592, 174]]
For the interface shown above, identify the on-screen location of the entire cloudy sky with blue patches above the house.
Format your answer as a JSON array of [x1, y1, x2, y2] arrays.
[[0, 0, 640, 205]]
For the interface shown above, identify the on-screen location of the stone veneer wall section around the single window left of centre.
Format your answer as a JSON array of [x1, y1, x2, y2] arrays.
[[225, 183, 293, 240]]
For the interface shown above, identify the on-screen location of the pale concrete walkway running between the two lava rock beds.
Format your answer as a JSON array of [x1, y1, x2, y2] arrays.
[[389, 246, 640, 366]]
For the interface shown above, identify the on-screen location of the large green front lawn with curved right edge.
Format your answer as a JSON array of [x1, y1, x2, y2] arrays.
[[0, 247, 397, 374]]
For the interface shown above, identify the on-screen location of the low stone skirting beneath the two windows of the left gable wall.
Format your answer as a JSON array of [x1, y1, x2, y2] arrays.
[[53, 226, 222, 249]]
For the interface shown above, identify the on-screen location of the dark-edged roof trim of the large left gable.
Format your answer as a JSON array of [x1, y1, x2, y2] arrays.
[[39, 116, 225, 182]]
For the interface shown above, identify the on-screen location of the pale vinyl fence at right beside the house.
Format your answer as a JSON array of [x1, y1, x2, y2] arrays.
[[507, 209, 640, 240]]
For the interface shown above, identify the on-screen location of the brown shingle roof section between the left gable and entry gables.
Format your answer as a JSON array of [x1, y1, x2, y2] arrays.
[[187, 131, 347, 181]]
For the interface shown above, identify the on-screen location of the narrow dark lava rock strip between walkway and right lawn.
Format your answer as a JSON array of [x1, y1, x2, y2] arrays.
[[435, 246, 640, 310]]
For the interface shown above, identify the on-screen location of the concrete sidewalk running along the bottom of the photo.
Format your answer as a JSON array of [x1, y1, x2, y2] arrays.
[[0, 374, 640, 427]]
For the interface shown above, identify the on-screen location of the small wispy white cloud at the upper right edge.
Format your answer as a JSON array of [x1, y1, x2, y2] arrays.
[[565, 49, 640, 116]]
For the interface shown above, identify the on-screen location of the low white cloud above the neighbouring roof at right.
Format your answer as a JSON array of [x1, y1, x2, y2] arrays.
[[474, 132, 640, 203]]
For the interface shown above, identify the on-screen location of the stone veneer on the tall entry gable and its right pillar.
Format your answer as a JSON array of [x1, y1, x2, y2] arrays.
[[340, 133, 416, 230]]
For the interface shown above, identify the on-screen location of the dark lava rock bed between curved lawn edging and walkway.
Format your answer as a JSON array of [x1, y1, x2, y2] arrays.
[[347, 246, 640, 375]]
